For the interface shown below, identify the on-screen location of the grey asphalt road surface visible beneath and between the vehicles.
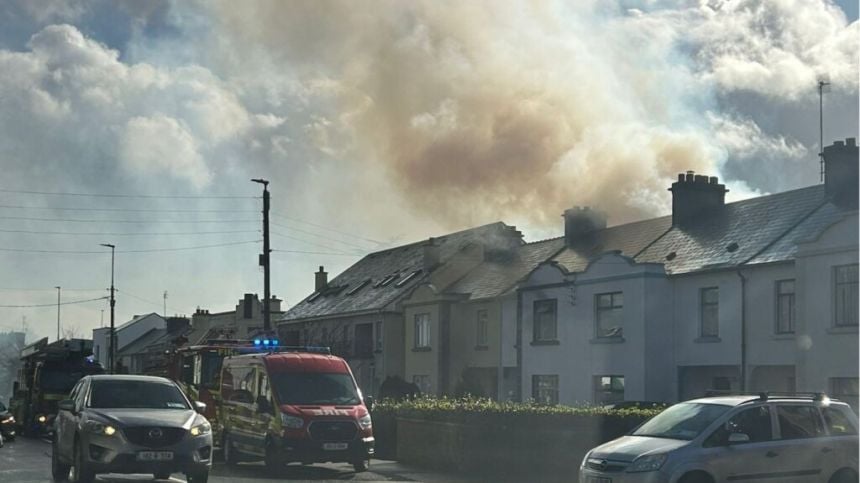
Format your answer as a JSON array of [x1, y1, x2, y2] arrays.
[[0, 438, 475, 483]]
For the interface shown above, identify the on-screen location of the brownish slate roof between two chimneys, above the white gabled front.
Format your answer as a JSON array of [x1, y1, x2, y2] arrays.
[[553, 216, 672, 272]]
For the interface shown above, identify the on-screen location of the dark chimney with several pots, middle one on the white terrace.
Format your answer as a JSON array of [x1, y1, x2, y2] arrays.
[[669, 171, 729, 226]]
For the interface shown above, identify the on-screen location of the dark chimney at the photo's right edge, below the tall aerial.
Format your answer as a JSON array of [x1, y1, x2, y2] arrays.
[[824, 138, 860, 209]]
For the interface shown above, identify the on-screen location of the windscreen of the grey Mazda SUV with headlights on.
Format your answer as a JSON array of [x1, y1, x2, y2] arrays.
[[88, 381, 191, 410]]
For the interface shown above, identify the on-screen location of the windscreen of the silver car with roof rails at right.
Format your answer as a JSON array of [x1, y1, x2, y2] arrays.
[[632, 403, 731, 440]]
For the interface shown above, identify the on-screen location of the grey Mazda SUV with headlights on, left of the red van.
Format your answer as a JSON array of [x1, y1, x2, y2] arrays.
[[51, 375, 212, 483]]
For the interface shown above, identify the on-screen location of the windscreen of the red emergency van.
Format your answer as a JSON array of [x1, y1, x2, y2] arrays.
[[272, 372, 361, 405]]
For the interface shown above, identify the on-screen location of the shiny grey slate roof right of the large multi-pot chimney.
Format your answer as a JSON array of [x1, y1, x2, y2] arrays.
[[635, 185, 826, 275]]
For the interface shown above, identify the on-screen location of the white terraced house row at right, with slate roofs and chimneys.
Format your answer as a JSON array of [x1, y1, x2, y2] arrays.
[[519, 139, 858, 408]]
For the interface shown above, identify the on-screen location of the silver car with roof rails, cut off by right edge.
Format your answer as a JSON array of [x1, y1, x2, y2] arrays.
[[579, 394, 858, 483]]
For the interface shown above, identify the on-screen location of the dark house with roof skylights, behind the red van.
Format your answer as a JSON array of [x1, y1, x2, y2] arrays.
[[278, 223, 522, 394]]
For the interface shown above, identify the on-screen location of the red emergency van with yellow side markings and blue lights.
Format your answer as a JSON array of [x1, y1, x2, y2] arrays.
[[220, 351, 374, 472]]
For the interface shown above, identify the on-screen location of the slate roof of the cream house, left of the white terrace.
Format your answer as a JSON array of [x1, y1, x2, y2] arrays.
[[445, 237, 564, 300]]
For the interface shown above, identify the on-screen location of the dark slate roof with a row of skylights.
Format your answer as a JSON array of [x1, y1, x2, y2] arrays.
[[280, 222, 514, 321]]
